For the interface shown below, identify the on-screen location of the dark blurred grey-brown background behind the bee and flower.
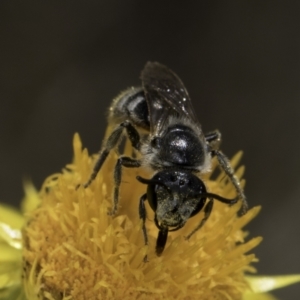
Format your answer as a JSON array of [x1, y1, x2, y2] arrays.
[[0, 0, 300, 300]]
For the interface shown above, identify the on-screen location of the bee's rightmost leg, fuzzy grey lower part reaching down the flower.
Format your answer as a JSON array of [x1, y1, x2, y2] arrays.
[[211, 150, 248, 215]]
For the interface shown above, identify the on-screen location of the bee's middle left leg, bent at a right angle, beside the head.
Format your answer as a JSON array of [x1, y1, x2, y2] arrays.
[[109, 156, 141, 215]]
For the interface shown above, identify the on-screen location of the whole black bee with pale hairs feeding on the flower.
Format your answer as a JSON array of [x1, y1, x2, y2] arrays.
[[84, 62, 247, 255]]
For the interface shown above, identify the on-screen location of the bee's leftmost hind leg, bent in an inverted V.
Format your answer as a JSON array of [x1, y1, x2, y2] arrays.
[[83, 121, 140, 188]]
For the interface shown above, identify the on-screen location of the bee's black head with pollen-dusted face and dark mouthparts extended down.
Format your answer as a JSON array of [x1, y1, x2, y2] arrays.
[[137, 169, 206, 255]]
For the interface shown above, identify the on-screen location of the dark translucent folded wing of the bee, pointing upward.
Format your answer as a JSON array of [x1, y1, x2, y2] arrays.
[[141, 62, 201, 135]]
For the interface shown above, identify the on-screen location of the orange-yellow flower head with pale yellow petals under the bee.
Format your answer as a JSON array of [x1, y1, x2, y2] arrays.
[[0, 135, 300, 300]]
